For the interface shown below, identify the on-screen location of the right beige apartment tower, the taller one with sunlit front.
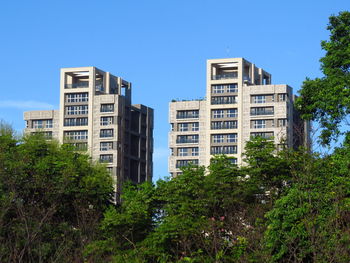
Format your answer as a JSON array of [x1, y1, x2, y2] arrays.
[[169, 58, 310, 176]]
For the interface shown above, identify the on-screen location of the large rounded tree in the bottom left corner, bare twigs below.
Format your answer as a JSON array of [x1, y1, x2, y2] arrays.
[[0, 129, 113, 262]]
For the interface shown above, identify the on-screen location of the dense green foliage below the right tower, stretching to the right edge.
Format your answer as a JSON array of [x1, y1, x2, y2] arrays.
[[85, 138, 350, 262]]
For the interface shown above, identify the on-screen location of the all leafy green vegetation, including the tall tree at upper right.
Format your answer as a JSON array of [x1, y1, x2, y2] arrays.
[[0, 12, 350, 263]]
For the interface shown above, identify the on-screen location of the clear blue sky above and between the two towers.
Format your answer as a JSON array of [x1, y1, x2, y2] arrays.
[[0, 0, 350, 180]]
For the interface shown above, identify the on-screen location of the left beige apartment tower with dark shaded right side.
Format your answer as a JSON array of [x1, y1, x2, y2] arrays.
[[24, 67, 153, 198]]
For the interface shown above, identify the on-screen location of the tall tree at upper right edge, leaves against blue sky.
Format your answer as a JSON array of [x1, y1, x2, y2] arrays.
[[297, 11, 350, 144]]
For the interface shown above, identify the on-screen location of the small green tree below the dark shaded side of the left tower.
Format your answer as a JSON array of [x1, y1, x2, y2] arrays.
[[85, 182, 157, 263]]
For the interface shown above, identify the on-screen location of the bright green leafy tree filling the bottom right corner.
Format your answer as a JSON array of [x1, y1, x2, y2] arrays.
[[264, 146, 350, 263]]
